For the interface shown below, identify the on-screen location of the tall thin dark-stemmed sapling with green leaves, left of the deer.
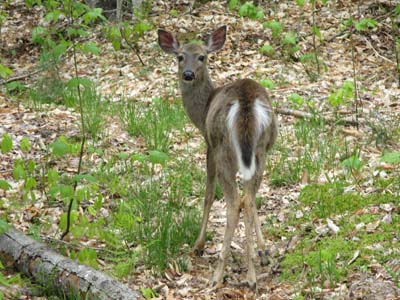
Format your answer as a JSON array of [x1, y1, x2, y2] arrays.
[[27, 0, 104, 239]]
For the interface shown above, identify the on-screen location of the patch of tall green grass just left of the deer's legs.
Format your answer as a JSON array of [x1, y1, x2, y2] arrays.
[[88, 146, 203, 277]]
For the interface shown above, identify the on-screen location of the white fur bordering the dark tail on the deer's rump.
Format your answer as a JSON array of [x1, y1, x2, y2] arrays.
[[226, 99, 271, 181]]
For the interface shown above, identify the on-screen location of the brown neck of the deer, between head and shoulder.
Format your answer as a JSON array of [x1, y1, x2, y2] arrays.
[[180, 75, 214, 135]]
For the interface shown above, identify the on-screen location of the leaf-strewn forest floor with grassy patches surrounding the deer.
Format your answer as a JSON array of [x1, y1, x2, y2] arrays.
[[0, 0, 400, 300]]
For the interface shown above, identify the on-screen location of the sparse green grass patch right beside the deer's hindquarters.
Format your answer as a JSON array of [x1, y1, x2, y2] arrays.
[[267, 118, 346, 186]]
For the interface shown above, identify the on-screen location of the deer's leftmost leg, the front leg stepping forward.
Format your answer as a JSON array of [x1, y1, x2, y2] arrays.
[[193, 148, 216, 255]]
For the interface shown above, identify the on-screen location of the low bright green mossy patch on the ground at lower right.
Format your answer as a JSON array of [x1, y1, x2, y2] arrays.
[[278, 183, 400, 294]]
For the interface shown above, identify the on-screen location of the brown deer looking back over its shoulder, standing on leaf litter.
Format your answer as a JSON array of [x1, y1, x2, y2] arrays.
[[158, 25, 278, 290]]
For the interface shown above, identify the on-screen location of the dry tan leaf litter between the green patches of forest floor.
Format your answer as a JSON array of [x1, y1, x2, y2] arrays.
[[0, 0, 400, 299]]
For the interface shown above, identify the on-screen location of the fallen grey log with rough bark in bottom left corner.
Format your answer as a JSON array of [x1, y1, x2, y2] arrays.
[[0, 229, 142, 300]]
